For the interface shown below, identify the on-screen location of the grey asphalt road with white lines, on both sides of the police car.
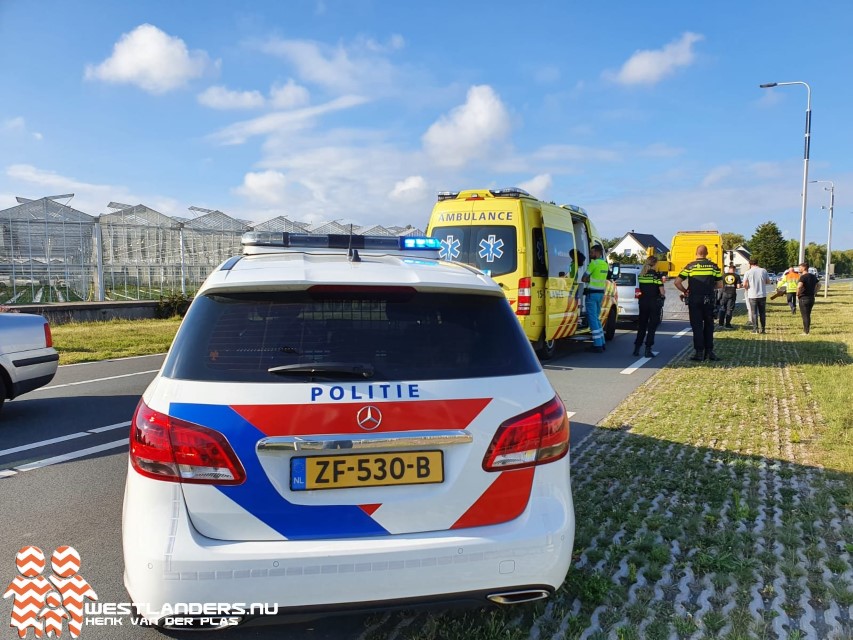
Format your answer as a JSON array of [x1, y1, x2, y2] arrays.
[[0, 321, 691, 640]]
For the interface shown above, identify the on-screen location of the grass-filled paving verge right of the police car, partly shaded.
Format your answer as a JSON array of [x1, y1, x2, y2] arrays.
[[362, 284, 853, 640]]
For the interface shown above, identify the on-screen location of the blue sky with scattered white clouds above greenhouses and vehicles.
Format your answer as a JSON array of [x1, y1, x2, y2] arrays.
[[0, 0, 853, 249]]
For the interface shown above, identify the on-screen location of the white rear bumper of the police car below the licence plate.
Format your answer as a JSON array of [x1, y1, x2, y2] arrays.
[[123, 458, 574, 622]]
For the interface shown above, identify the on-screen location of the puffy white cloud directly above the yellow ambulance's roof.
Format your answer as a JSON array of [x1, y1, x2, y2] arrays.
[[422, 85, 510, 167]]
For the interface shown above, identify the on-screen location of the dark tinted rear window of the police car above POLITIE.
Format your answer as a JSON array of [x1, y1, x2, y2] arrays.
[[163, 287, 540, 384]]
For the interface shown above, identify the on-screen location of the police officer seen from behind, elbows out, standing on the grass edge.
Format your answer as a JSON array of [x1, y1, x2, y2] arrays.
[[675, 244, 723, 361]]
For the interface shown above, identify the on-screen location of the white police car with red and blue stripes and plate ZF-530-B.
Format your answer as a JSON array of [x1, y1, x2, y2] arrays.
[[122, 232, 574, 627]]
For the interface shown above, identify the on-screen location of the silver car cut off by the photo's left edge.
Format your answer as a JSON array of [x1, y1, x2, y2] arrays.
[[0, 312, 59, 409]]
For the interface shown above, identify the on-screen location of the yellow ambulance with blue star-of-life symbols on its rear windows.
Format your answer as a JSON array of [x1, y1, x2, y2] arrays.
[[427, 188, 617, 360]]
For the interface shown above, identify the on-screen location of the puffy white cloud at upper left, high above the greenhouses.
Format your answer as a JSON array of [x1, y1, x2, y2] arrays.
[[85, 24, 211, 94]]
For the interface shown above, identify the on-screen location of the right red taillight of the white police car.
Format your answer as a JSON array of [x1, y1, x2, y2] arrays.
[[483, 396, 569, 471]]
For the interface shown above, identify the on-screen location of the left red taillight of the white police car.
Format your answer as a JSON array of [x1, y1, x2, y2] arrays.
[[130, 401, 246, 484]]
